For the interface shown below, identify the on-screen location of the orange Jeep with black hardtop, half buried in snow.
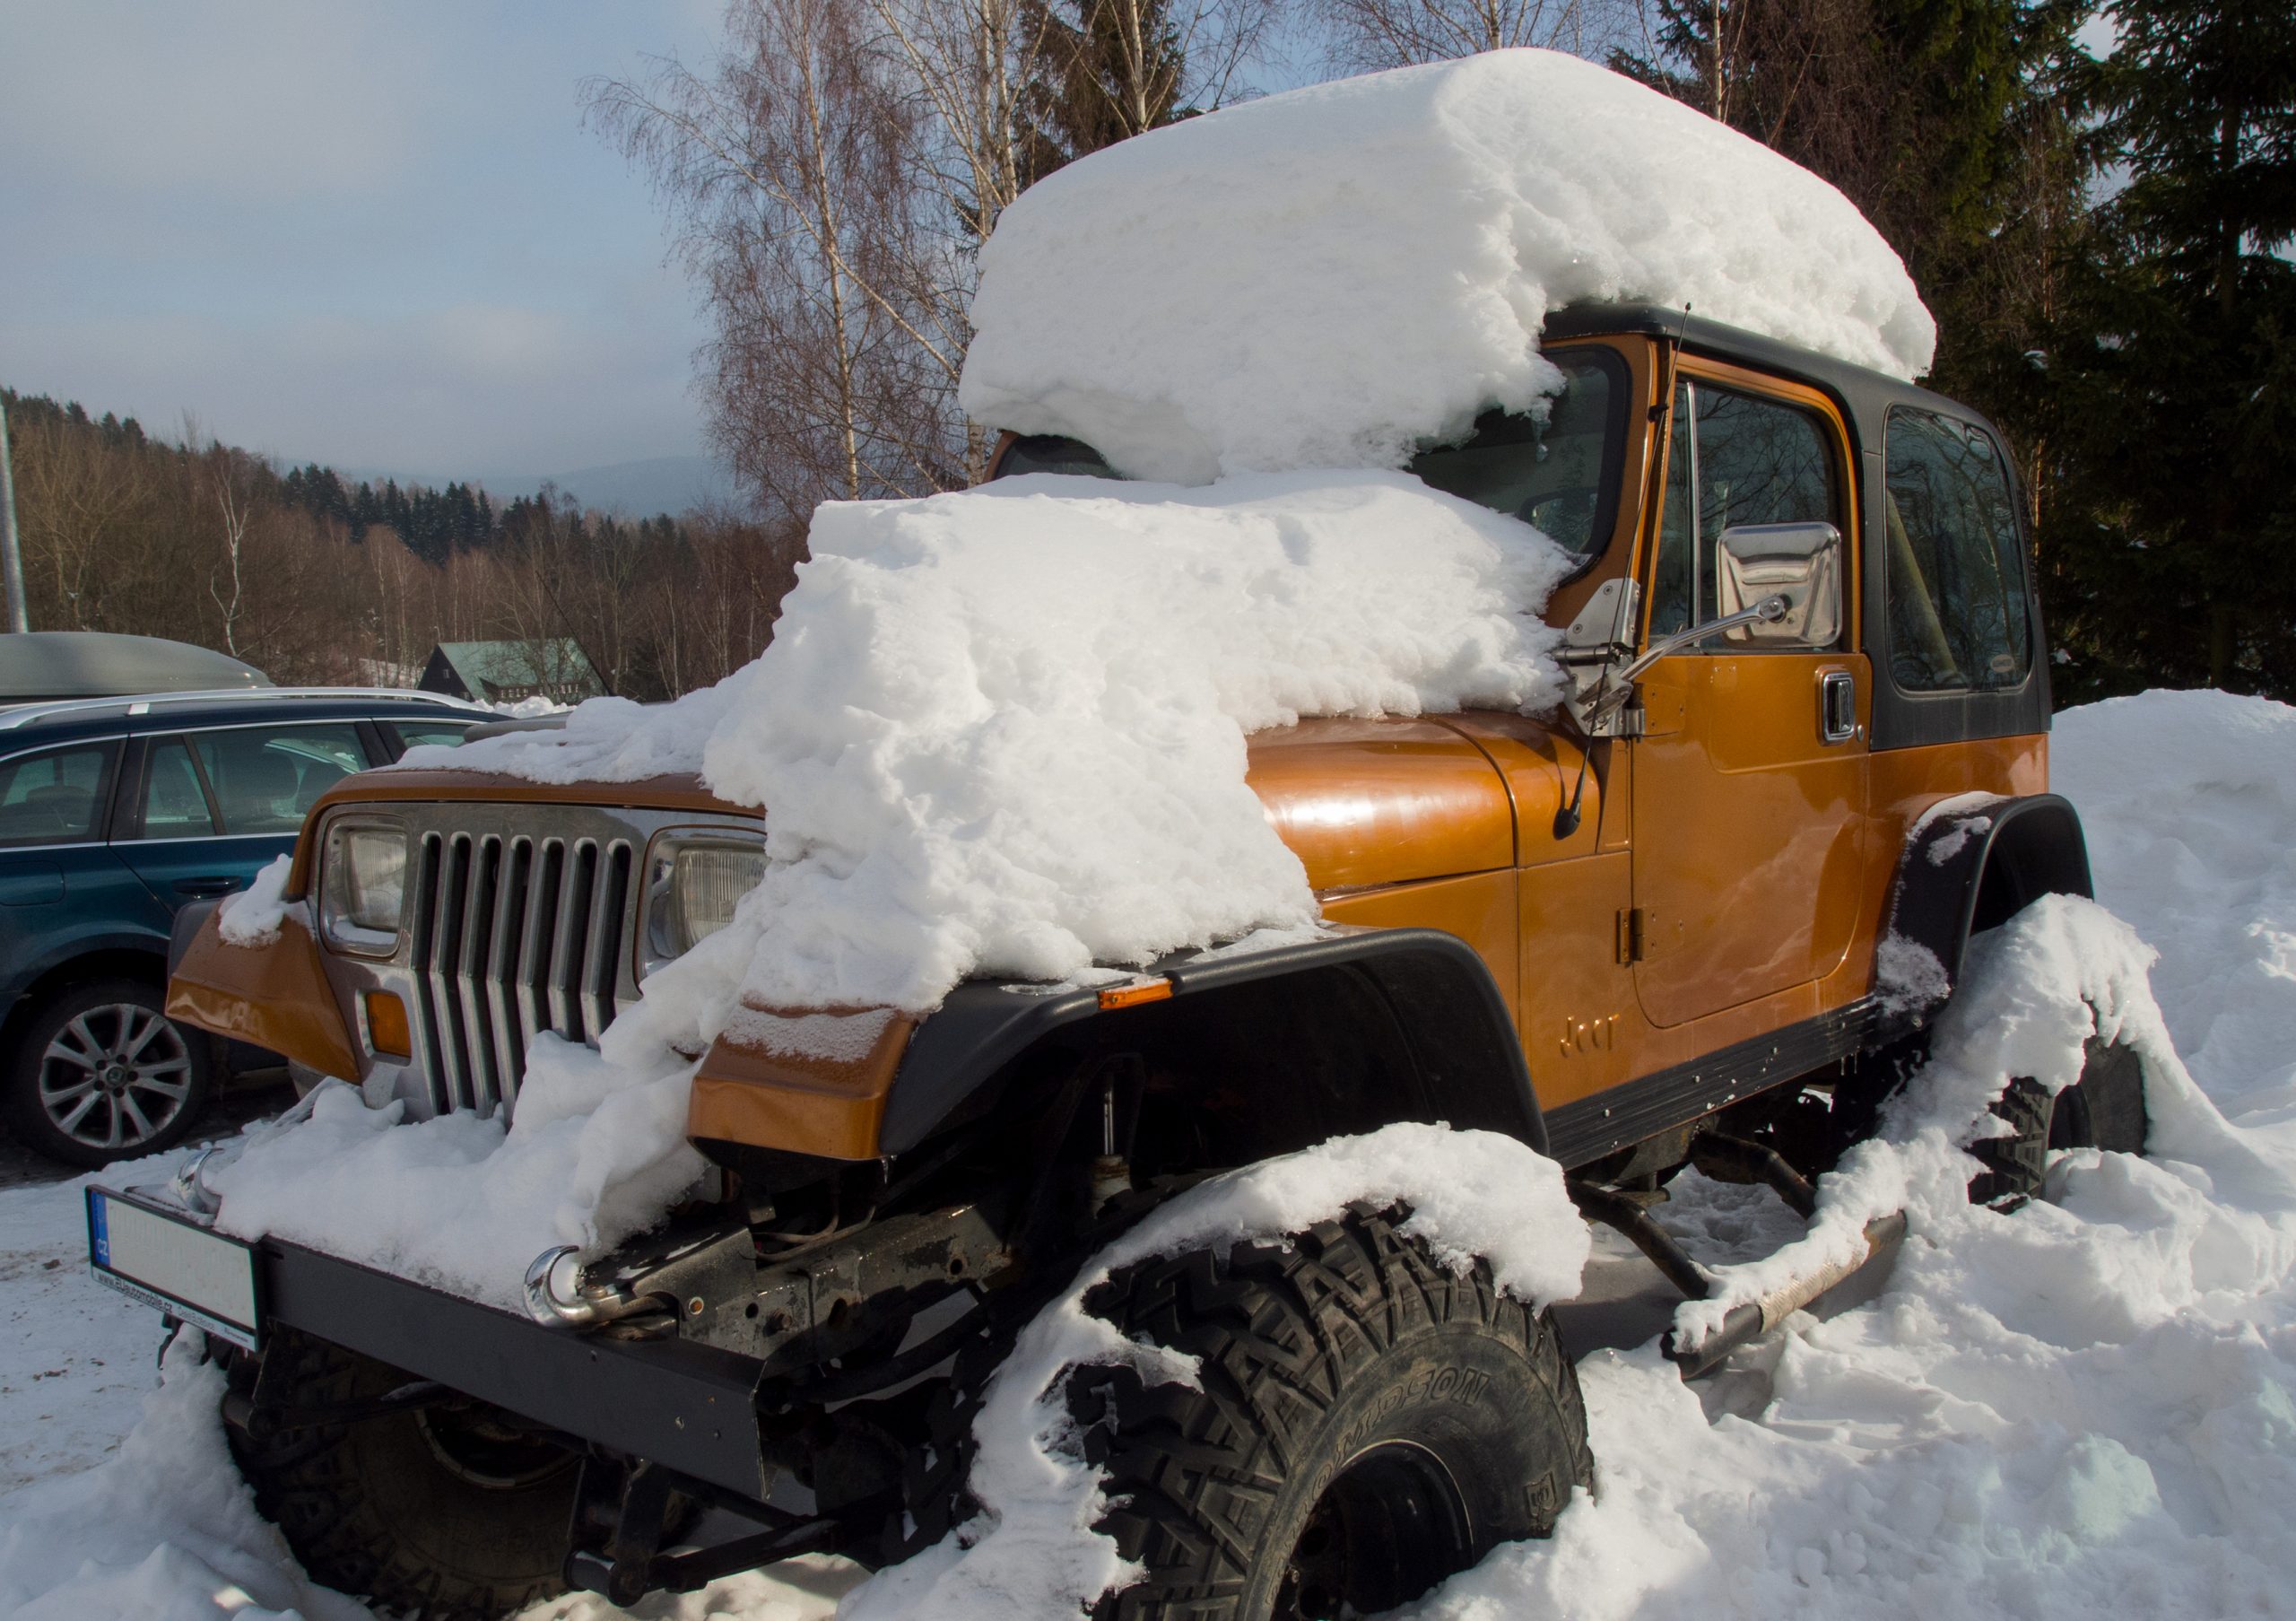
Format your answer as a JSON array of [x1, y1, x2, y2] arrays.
[[94, 305, 2142, 1621]]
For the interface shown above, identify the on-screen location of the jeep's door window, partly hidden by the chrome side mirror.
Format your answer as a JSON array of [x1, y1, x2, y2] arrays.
[[1651, 379, 1841, 639]]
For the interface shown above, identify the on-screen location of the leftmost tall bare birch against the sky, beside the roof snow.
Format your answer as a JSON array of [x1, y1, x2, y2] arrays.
[[586, 0, 962, 514]]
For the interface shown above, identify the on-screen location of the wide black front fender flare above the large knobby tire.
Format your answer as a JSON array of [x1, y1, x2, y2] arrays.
[[877, 928, 1547, 1155]]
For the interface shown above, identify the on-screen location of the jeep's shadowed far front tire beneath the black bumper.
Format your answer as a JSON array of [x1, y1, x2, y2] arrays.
[[225, 1332, 577, 1621]]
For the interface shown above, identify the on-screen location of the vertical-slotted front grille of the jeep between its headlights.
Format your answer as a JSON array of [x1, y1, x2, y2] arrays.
[[409, 832, 636, 1113]]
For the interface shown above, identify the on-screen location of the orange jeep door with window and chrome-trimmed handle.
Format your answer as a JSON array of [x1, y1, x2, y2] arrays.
[[1631, 358, 1866, 1026]]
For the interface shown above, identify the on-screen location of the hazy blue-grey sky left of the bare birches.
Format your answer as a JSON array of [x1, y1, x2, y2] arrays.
[[0, 0, 718, 480]]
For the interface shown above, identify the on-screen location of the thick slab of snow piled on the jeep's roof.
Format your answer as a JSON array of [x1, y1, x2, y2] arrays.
[[960, 50, 1935, 482]]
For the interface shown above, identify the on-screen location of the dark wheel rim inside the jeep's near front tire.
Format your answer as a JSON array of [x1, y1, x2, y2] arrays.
[[1272, 1442, 1472, 1621]]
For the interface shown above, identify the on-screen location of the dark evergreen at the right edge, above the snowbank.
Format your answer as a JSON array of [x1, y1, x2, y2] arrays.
[[2043, 0, 2296, 696]]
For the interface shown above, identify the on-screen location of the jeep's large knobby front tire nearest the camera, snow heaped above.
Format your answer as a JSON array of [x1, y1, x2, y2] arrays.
[[1070, 1212, 1594, 1621]]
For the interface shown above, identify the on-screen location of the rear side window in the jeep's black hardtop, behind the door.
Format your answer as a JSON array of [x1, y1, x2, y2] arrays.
[[1883, 406, 2032, 693]]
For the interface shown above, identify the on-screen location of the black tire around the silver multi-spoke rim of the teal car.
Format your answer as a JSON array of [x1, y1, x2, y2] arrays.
[[0, 978, 213, 1169]]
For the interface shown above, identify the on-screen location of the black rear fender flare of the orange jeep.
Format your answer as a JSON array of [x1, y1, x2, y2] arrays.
[[1876, 795, 2096, 1033]]
